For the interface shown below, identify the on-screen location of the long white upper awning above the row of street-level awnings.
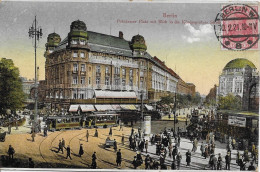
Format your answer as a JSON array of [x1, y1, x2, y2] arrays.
[[95, 90, 137, 99]]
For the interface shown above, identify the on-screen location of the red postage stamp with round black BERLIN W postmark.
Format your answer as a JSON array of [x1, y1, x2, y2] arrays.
[[214, 4, 259, 50]]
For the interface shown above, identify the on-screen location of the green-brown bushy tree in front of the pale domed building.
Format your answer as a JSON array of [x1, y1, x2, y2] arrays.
[[219, 94, 242, 110]]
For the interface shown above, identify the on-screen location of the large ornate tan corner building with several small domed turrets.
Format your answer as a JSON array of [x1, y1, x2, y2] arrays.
[[44, 20, 193, 109]]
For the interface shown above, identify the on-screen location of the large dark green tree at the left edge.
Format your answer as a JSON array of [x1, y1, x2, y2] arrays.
[[0, 58, 25, 113]]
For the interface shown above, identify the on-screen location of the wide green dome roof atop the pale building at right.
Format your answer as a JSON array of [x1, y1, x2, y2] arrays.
[[224, 58, 256, 69]]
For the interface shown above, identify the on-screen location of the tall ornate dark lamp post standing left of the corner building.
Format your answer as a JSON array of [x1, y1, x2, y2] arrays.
[[28, 16, 42, 132]]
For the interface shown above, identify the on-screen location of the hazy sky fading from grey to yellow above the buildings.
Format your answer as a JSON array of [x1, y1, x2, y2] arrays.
[[0, 1, 259, 95]]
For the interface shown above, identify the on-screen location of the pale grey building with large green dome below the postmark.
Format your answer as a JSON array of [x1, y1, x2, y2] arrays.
[[217, 58, 259, 110]]
